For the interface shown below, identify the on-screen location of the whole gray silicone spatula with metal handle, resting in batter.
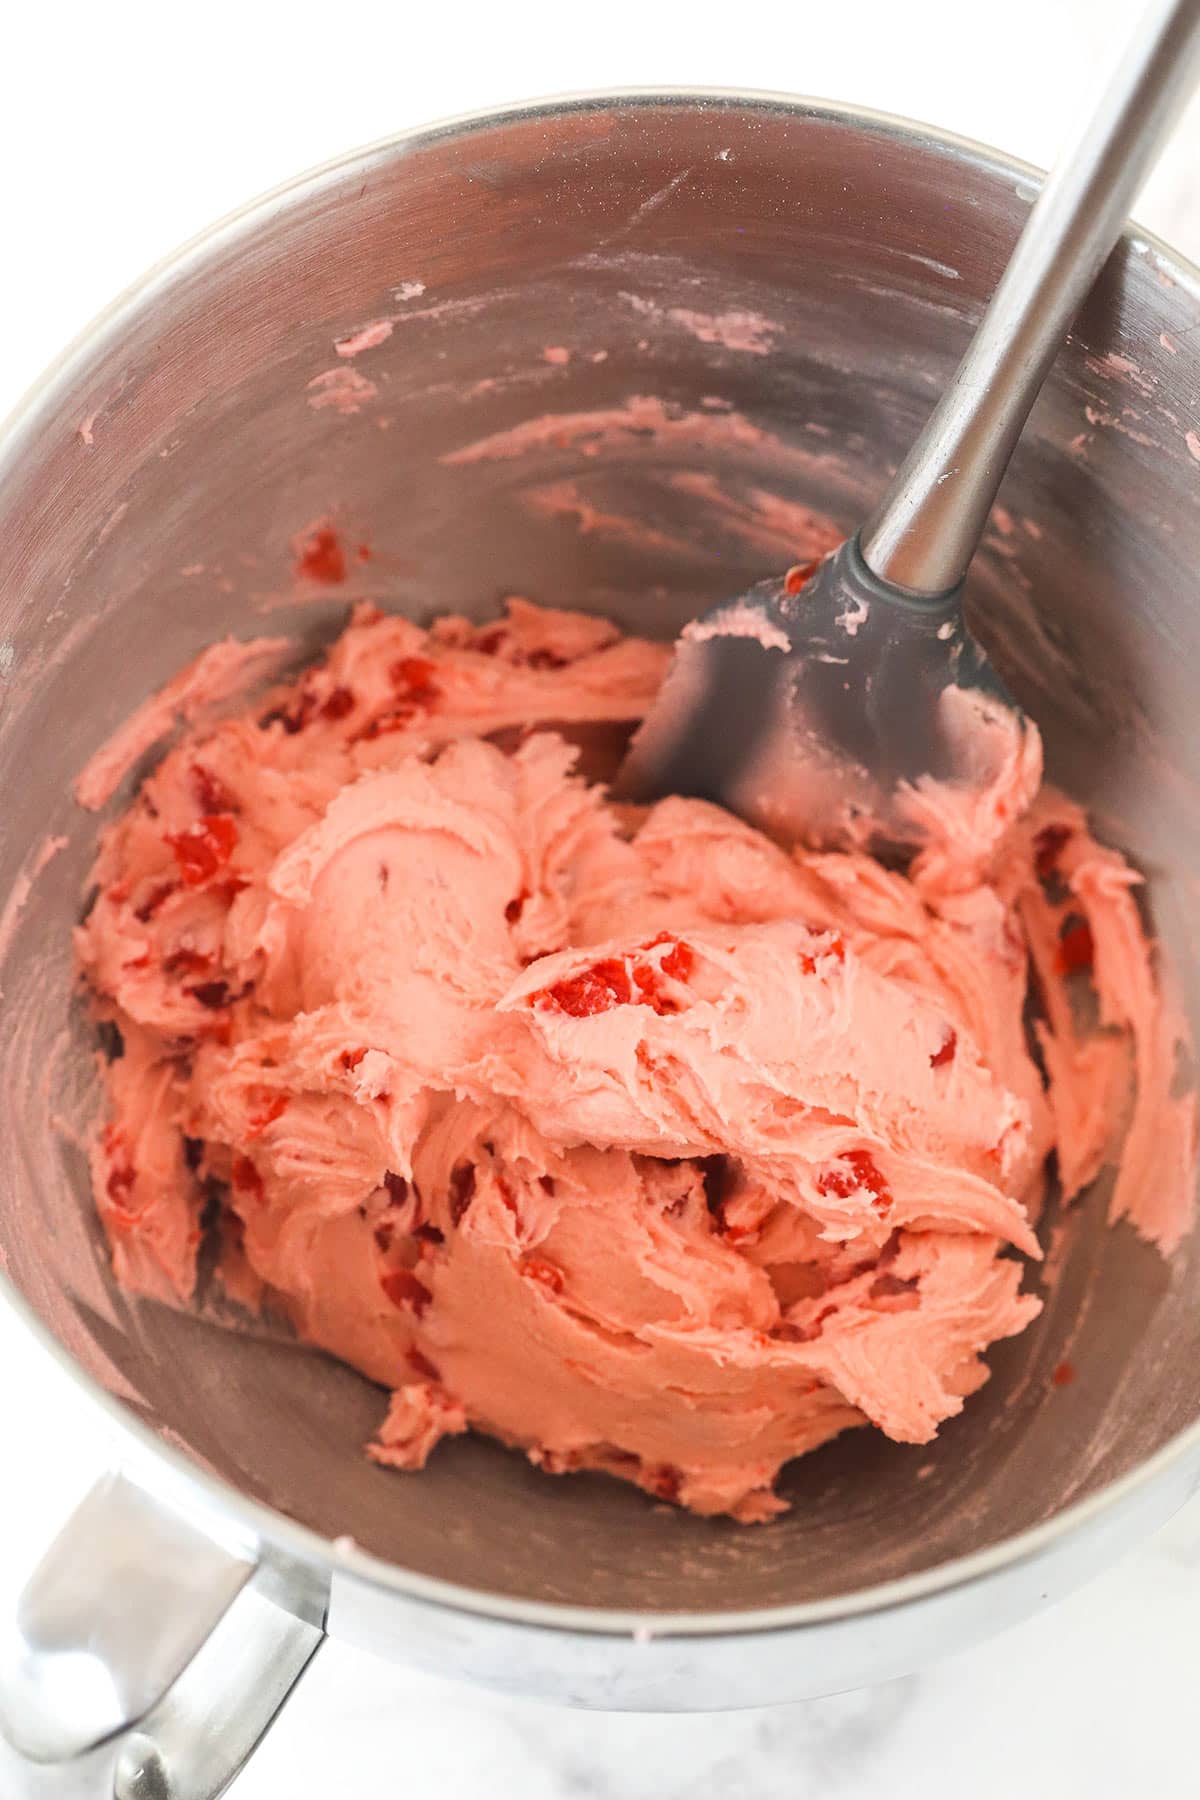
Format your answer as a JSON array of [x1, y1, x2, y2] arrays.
[[617, 0, 1200, 842]]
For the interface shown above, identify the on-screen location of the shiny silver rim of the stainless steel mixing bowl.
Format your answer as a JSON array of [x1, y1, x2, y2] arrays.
[[0, 86, 1200, 1638]]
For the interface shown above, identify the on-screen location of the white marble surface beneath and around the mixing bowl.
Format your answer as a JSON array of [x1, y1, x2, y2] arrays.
[[0, 0, 1200, 1800]]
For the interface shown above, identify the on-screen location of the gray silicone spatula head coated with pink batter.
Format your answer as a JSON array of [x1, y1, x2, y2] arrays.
[[617, 538, 1022, 848]]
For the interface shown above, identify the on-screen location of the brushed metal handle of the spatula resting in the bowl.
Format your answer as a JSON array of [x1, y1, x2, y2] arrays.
[[860, 0, 1200, 599]]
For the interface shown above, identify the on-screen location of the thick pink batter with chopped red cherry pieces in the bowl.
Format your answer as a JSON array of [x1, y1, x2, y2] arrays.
[[77, 601, 1195, 1521]]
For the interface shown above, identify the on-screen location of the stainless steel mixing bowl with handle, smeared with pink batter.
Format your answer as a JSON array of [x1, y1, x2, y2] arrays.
[[0, 94, 1200, 1795]]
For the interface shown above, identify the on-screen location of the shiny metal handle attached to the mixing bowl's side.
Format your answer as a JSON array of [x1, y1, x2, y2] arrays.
[[0, 1472, 324, 1800]]
